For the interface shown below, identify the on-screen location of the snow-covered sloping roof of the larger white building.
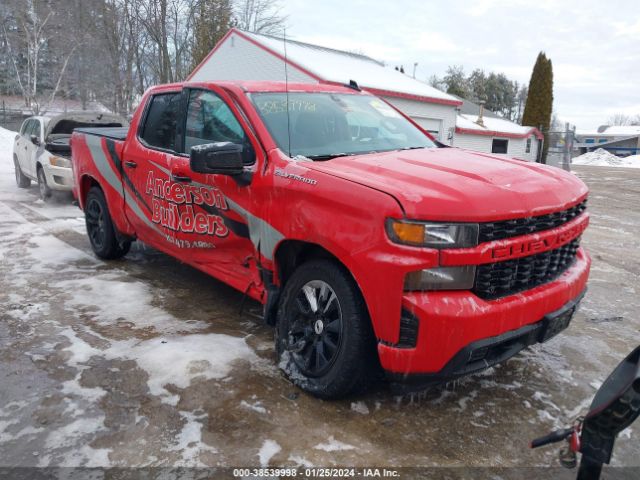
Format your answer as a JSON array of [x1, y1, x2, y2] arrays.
[[238, 31, 460, 105]]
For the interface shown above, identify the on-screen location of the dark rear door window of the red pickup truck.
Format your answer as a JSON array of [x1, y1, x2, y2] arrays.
[[140, 92, 181, 151]]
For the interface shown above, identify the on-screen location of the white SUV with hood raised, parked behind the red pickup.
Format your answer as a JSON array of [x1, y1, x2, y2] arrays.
[[13, 112, 128, 200]]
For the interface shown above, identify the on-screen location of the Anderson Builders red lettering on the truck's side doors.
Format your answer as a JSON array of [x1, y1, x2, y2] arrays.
[[145, 171, 229, 237]]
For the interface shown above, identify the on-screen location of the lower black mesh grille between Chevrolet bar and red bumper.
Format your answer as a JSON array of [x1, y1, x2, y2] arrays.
[[472, 238, 580, 300]]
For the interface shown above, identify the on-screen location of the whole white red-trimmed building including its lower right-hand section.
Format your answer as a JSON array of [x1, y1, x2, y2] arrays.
[[188, 28, 541, 161]]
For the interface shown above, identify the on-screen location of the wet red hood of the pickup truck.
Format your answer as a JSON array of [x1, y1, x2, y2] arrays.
[[305, 148, 588, 222]]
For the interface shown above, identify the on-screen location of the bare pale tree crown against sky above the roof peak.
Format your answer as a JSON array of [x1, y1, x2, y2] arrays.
[[234, 0, 287, 34]]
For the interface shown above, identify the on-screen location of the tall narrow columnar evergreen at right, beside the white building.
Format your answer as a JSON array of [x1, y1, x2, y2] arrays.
[[522, 52, 553, 163]]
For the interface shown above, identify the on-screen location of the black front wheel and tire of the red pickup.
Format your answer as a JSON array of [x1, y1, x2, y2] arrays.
[[276, 260, 378, 399]]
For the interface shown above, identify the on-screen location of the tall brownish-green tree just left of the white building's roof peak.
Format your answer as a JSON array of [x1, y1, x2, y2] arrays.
[[191, 0, 232, 68]]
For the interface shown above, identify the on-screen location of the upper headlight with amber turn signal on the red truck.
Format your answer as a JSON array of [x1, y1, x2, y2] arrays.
[[387, 218, 479, 248]]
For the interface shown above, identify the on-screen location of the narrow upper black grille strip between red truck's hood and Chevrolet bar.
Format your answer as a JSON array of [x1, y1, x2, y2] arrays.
[[479, 199, 587, 243]]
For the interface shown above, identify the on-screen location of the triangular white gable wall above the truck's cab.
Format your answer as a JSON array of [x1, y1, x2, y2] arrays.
[[191, 33, 318, 83]]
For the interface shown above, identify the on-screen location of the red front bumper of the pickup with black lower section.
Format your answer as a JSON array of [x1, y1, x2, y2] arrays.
[[378, 248, 591, 383]]
